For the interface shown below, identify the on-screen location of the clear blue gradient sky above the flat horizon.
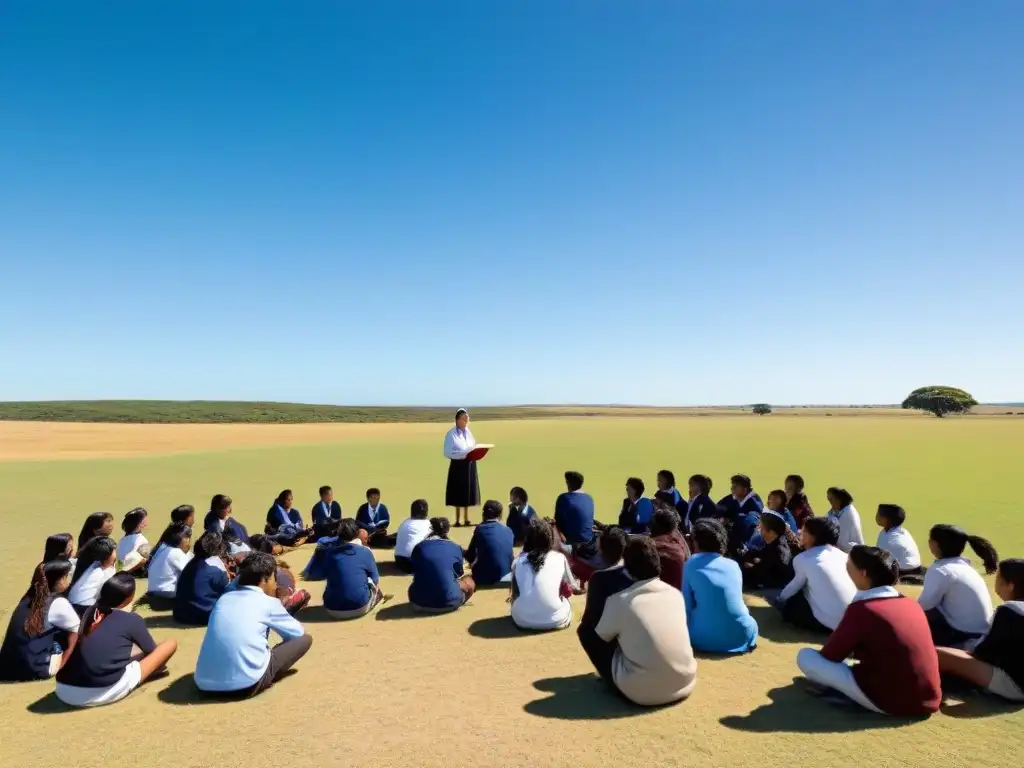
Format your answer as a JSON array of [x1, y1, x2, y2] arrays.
[[0, 0, 1024, 404]]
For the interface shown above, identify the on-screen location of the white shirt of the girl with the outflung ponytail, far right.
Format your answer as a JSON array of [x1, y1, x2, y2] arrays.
[[918, 557, 992, 635]]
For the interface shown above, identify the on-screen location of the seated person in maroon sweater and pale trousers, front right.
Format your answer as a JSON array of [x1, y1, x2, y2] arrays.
[[797, 546, 942, 717]]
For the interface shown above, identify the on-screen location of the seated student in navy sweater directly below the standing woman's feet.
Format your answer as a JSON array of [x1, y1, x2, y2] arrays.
[[409, 517, 476, 613]]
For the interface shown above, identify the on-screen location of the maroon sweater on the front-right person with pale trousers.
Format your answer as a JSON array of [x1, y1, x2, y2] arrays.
[[821, 596, 942, 717]]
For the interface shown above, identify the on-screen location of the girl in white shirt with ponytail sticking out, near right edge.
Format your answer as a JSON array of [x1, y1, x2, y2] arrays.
[[918, 525, 999, 650]]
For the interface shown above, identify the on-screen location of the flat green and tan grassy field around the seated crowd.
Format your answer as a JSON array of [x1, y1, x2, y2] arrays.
[[0, 415, 1024, 768]]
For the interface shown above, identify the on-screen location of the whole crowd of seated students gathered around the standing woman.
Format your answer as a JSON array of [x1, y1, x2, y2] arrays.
[[0, 470, 1024, 717]]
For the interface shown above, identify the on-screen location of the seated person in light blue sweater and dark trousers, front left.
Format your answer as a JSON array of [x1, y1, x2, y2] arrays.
[[195, 552, 313, 697]]
